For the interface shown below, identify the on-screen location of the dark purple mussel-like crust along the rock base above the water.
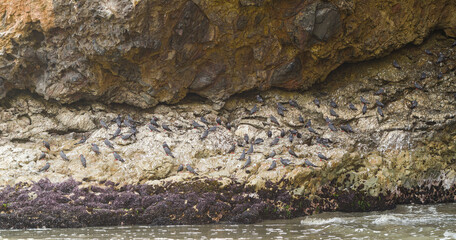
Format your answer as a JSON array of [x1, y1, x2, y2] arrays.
[[0, 179, 456, 229]]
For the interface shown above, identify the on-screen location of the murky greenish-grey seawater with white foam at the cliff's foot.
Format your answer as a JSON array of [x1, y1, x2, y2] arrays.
[[0, 203, 456, 240]]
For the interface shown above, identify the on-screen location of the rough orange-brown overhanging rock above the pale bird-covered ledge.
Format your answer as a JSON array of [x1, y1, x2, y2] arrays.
[[0, 0, 456, 108]]
